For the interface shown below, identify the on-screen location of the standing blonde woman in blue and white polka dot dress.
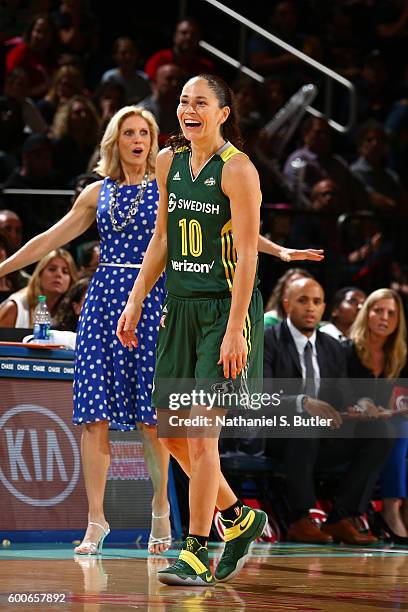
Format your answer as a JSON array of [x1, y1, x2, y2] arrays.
[[0, 106, 171, 555]]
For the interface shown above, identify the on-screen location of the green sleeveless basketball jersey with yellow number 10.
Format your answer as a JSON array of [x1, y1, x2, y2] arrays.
[[166, 142, 258, 297]]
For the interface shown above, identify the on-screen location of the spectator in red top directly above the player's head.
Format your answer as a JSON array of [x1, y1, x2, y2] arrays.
[[145, 17, 214, 81]]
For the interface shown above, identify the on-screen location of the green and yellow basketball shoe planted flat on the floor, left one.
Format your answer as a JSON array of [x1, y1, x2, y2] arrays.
[[157, 537, 215, 587]]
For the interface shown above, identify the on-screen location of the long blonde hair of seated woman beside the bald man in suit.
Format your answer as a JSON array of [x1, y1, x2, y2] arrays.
[[350, 289, 407, 378]]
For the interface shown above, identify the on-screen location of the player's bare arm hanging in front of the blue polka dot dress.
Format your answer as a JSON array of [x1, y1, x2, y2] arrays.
[[116, 149, 173, 348]]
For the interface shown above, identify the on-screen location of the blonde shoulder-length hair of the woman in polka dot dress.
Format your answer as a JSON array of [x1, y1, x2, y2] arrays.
[[94, 106, 159, 181]]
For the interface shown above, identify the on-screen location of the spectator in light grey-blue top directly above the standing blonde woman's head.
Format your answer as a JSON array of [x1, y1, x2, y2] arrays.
[[102, 36, 151, 104]]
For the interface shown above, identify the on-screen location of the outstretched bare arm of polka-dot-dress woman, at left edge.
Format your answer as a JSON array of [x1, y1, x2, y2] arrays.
[[0, 181, 101, 277]]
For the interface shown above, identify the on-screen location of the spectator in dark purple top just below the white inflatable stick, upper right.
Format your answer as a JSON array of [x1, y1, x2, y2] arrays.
[[284, 117, 368, 212]]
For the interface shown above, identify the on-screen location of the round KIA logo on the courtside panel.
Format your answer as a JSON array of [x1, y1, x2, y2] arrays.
[[0, 404, 80, 506]]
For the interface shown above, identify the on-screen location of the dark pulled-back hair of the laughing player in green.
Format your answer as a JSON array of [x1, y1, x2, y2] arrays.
[[166, 74, 243, 152]]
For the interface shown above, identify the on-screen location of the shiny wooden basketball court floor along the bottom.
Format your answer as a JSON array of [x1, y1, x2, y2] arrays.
[[0, 543, 408, 612]]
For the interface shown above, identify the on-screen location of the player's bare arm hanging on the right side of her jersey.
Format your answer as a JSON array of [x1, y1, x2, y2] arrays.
[[219, 155, 262, 378]]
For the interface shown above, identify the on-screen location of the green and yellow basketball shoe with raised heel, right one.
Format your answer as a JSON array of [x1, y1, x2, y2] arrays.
[[215, 506, 268, 582]]
